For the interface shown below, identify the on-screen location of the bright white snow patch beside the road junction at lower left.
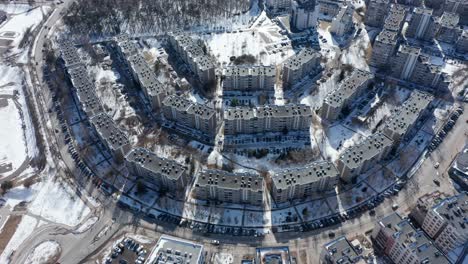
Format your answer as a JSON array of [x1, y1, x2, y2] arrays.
[[29, 179, 90, 226]]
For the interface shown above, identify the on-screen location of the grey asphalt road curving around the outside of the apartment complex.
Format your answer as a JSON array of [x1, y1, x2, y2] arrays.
[[8, 0, 468, 263]]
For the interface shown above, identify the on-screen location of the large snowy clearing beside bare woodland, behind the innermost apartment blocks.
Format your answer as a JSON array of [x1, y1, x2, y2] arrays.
[[202, 12, 294, 66]]
